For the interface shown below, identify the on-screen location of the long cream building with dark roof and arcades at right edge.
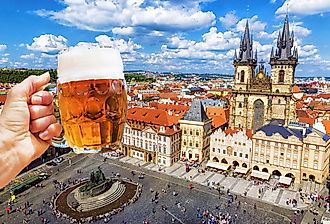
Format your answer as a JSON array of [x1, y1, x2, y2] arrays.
[[252, 123, 330, 183]]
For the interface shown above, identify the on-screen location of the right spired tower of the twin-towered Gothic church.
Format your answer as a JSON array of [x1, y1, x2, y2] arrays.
[[270, 16, 298, 93]]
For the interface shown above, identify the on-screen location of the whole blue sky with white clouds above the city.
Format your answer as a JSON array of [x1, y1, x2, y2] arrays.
[[0, 0, 330, 76]]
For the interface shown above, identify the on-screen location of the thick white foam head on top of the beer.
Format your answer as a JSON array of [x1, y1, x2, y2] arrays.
[[57, 45, 124, 83]]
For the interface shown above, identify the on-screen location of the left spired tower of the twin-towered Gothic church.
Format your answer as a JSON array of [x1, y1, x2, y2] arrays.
[[233, 21, 257, 90]]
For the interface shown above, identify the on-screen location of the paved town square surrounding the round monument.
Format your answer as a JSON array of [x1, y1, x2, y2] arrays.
[[0, 155, 328, 224]]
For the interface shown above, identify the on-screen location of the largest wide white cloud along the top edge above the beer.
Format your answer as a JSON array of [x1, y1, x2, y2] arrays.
[[36, 0, 215, 31]]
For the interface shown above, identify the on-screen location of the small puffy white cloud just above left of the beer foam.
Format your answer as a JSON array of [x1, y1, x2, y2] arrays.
[[26, 34, 67, 52]]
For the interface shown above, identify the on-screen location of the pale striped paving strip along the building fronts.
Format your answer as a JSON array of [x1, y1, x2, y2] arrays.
[[110, 157, 321, 209]]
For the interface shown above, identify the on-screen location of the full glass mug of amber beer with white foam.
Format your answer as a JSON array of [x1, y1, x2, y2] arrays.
[[57, 46, 127, 153]]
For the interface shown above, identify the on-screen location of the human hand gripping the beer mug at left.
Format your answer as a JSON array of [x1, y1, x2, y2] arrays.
[[0, 72, 62, 187]]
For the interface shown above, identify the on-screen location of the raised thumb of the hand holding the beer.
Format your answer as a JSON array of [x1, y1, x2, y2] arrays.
[[8, 72, 50, 101]]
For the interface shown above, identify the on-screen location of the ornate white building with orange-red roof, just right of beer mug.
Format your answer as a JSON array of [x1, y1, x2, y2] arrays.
[[121, 108, 181, 166]]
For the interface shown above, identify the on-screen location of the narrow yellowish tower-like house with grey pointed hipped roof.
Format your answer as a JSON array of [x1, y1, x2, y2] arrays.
[[179, 100, 212, 162]]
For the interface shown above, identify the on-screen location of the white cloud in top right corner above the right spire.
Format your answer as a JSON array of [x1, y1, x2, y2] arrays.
[[276, 0, 330, 15]]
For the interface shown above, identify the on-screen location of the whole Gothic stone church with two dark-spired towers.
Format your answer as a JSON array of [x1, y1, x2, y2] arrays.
[[229, 17, 298, 131]]
